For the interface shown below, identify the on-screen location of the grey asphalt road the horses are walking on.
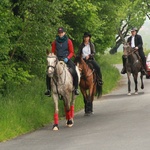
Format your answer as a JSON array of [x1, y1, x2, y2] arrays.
[[0, 63, 150, 150]]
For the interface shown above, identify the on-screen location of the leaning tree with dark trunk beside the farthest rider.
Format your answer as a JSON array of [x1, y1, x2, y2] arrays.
[[110, 0, 146, 54]]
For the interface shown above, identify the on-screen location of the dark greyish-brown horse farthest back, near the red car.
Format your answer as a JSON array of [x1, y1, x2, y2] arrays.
[[123, 43, 144, 95]]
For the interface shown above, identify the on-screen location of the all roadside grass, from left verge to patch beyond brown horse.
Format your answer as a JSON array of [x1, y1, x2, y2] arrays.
[[0, 54, 124, 141]]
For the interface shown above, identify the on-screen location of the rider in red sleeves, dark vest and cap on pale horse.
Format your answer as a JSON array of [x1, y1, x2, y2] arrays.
[[45, 27, 79, 96]]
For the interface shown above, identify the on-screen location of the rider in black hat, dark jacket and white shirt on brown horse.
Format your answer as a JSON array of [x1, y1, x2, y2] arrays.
[[77, 32, 103, 85]]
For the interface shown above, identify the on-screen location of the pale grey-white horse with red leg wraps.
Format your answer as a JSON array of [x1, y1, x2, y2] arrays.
[[47, 53, 80, 130]]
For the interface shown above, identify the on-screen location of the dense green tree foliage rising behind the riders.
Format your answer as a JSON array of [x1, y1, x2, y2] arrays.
[[0, 0, 149, 94]]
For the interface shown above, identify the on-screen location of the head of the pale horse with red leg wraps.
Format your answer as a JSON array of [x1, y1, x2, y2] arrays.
[[47, 53, 58, 77]]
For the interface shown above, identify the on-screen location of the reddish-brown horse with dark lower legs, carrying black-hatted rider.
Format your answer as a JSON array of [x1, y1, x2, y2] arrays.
[[74, 56, 102, 115]]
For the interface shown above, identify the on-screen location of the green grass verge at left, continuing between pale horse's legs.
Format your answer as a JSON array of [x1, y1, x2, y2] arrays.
[[0, 80, 83, 141]]
